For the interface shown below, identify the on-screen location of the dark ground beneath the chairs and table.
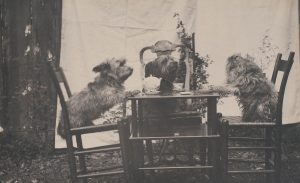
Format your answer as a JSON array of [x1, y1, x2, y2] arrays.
[[0, 132, 300, 183]]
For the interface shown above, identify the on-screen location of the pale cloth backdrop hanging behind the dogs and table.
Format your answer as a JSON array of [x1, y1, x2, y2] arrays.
[[56, 0, 300, 147]]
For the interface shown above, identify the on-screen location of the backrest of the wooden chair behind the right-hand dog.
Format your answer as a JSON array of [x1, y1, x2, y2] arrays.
[[271, 52, 295, 125]]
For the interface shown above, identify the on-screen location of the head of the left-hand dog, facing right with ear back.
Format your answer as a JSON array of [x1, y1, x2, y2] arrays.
[[93, 58, 133, 83]]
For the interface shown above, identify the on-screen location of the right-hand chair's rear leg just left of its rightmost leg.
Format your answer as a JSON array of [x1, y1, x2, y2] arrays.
[[265, 128, 272, 183]]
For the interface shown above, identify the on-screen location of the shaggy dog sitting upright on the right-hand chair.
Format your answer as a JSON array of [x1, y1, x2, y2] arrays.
[[226, 55, 277, 122]]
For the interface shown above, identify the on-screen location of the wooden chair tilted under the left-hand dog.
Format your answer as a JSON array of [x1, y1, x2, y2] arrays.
[[47, 61, 127, 183]]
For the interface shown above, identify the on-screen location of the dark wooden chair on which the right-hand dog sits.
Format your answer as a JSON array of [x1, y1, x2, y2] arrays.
[[222, 52, 295, 183]]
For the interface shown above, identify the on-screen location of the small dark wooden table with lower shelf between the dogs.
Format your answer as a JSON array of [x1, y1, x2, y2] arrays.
[[128, 92, 221, 182]]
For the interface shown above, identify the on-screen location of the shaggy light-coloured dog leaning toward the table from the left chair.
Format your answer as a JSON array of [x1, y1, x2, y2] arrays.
[[57, 58, 133, 139]]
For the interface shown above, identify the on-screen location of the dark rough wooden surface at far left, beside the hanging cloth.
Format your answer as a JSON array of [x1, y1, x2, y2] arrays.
[[0, 0, 62, 151]]
